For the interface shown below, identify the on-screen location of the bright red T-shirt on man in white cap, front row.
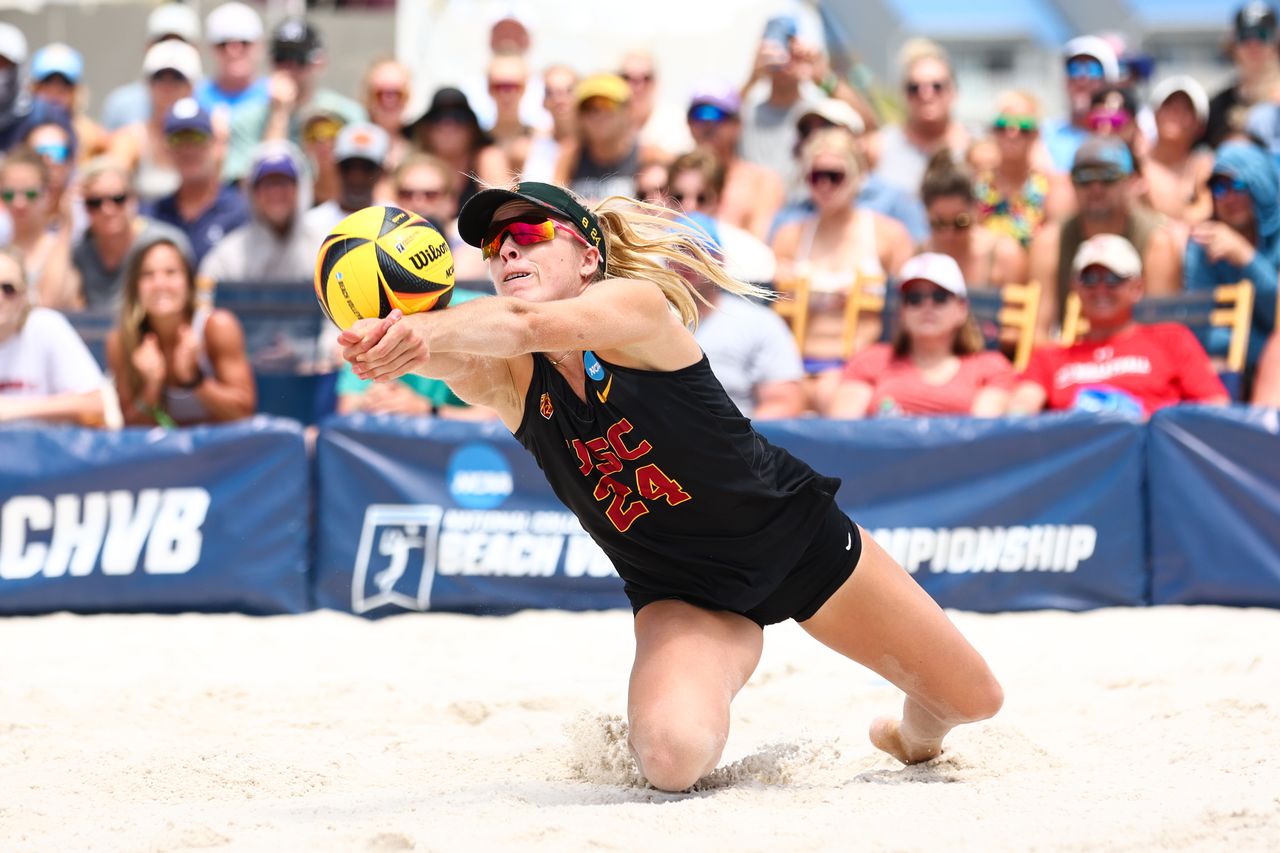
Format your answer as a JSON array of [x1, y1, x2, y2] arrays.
[[1023, 323, 1228, 418]]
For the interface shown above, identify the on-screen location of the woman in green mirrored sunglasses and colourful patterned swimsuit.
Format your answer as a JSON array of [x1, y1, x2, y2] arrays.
[[973, 91, 1065, 248]]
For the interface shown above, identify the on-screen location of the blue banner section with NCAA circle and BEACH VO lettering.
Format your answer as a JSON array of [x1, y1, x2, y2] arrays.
[[315, 415, 627, 616]]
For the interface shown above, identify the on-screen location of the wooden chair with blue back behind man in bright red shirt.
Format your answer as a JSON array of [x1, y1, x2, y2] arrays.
[[1061, 279, 1253, 373]]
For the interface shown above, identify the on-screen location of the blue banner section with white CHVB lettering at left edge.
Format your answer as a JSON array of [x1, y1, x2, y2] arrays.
[[0, 418, 310, 613]]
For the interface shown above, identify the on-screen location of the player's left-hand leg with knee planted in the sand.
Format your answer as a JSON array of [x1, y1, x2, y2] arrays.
[[627, 601, 764, 792]]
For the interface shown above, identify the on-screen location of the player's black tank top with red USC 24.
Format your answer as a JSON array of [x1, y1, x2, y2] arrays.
[[516, 352, 840, 612]]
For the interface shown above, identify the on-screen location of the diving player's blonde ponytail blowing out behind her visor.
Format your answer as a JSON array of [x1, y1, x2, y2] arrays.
[[593, 196, 773, 328]]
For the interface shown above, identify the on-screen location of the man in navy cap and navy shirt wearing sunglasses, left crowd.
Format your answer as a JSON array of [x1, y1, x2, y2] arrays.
[[142, 97, 250, 265]]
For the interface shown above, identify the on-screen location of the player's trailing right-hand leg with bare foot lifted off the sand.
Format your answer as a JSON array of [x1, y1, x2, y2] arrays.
[[800, 530, 1004, 763]]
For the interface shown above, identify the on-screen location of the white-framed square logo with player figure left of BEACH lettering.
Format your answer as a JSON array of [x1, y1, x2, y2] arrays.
[[351, 503, 444, 613]]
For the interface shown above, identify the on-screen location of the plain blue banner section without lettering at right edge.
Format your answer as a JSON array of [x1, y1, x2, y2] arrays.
[[1148, 406, 1280, 607]]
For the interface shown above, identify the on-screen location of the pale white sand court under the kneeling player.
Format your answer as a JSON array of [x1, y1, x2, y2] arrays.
[[0, 607, 1280, 852]]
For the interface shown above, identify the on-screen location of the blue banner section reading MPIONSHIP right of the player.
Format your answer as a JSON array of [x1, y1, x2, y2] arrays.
[[760, 414, 1147, 611]]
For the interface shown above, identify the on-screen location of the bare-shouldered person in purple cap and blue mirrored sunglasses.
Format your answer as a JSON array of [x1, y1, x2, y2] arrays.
[[686, 81, 786, 240]]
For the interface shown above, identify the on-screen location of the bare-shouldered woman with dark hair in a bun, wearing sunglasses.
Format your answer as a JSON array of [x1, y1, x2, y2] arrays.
[[920, 150, 1027, 295]]
